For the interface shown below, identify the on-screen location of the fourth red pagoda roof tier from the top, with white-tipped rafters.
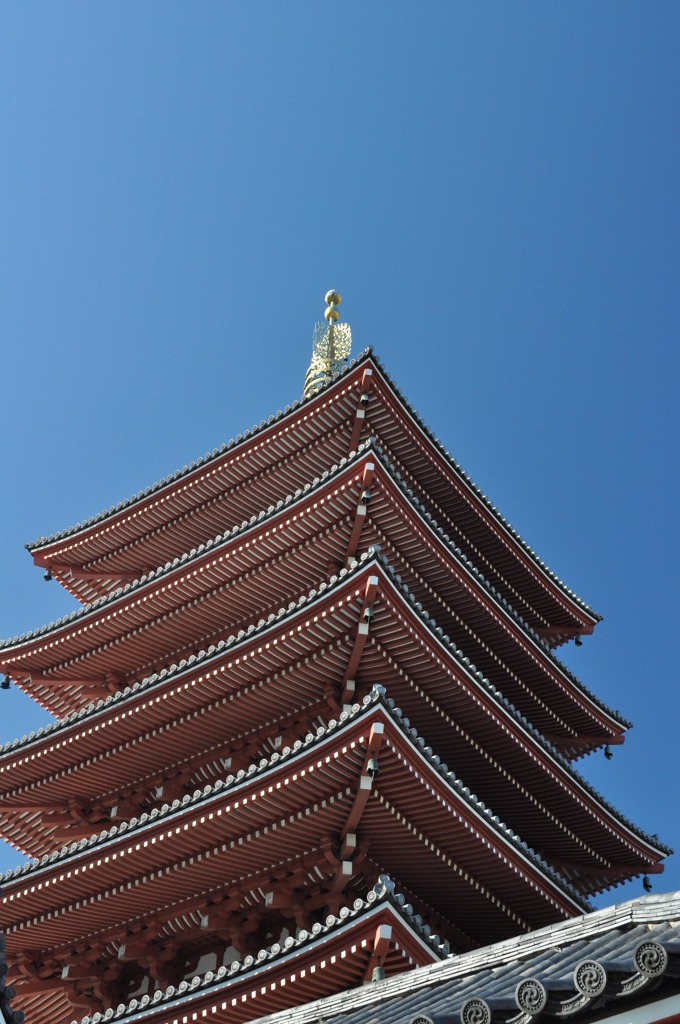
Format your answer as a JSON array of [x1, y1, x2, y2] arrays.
[[0, 691, 588, 945]]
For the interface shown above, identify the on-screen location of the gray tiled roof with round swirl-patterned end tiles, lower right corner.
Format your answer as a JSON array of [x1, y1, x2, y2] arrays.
[[248, 892, 680, 1024]]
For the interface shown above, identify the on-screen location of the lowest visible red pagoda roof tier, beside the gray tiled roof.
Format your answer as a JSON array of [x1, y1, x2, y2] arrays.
[[7, 876, 448, 1024]]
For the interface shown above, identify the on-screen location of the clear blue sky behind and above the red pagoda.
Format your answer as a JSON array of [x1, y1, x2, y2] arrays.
[[0, 0, 680, 902]]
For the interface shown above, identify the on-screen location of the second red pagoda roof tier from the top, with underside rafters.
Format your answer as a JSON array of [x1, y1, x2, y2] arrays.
[[0, 441, 630, 756]]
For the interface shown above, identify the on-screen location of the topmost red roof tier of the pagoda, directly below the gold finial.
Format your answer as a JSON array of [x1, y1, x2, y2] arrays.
[[28, 349, 599, 644]]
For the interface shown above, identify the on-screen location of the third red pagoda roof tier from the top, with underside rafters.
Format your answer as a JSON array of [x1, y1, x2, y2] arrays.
[[0, 556, 670, 892]]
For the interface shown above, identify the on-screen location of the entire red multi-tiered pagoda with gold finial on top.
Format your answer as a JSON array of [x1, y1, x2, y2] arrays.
[[0, 292, 670, 1024]]
